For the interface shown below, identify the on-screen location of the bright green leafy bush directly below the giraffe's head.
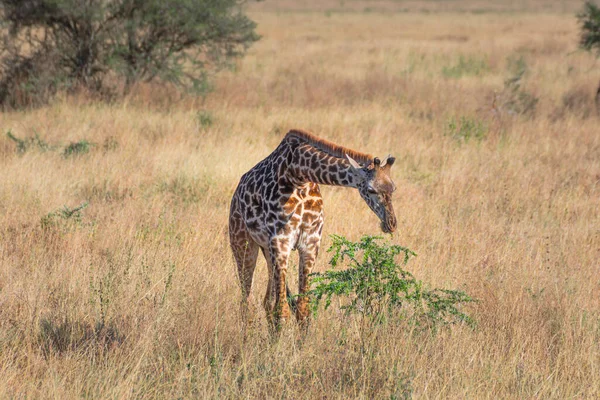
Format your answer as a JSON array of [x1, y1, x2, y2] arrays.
[[308, 235, 474, 336]]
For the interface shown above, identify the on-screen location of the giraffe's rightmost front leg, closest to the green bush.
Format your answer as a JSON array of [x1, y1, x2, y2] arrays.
[[296, 235, 321, 326]]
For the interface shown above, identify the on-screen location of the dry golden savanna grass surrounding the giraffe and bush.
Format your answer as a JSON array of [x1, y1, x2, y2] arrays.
[[0, 0, 600, 399]]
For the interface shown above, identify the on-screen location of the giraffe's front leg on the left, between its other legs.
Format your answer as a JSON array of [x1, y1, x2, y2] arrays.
[[264, 239, 291, 329]]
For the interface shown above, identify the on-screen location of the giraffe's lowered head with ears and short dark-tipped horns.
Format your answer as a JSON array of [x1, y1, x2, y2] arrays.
[[346, 155, 396, 233]]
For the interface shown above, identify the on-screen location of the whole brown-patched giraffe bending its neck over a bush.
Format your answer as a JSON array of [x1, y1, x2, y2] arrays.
[[229, 130, 396, 328]]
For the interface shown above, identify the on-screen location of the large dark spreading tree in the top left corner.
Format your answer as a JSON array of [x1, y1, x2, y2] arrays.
[[0, 0, 258, 106]]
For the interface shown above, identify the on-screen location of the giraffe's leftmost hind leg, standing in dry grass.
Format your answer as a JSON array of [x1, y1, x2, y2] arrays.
[[230, 225, 258, 325]]
